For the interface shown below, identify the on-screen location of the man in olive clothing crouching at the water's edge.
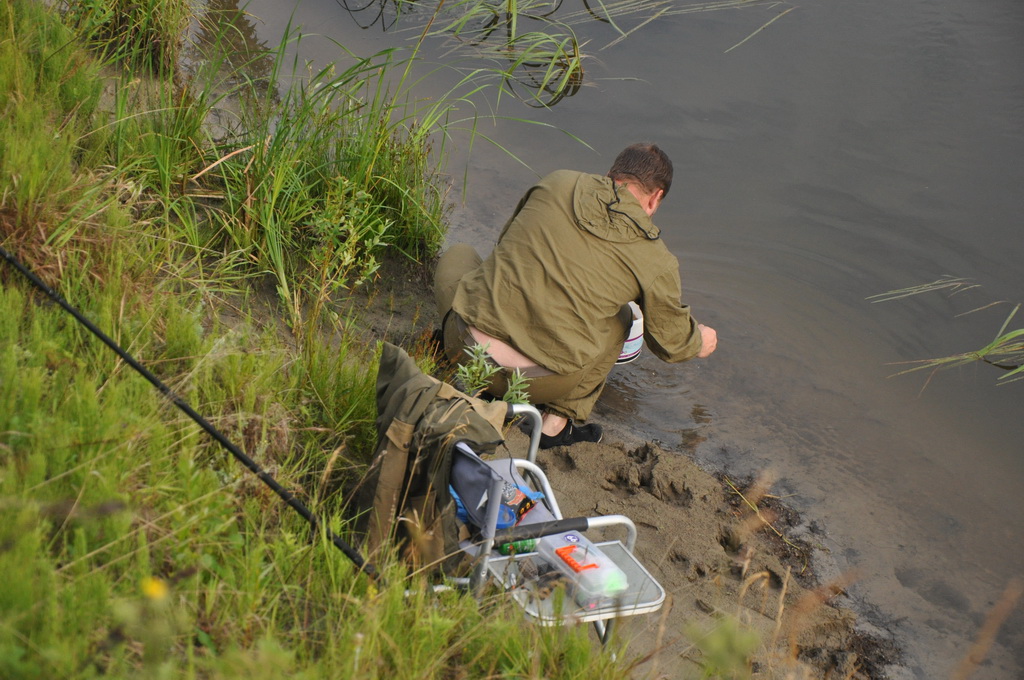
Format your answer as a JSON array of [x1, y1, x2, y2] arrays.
[[434, 143, 718, 449]]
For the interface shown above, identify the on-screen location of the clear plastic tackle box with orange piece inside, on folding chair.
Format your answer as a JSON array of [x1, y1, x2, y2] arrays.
[[537, 532, 629, 608]]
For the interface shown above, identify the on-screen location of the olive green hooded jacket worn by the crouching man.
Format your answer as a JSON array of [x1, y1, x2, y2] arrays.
[[453, 170, 700, 375]]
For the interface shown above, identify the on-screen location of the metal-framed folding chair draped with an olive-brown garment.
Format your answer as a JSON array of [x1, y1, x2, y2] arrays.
[[368, 343, 665, 642]]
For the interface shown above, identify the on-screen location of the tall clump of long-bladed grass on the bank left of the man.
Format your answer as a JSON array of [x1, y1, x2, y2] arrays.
[[184, 29, 447, 331]]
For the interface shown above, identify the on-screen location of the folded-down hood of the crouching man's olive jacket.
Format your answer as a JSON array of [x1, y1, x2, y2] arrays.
[[572, 174, 662, 243]]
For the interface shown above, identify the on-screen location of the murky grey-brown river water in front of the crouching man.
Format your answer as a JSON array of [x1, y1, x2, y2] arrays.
[[214, 0, 1024, 680]]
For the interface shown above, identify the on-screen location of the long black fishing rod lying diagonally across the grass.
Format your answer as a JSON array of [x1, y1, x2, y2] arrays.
[[0, 247, 378, 580]]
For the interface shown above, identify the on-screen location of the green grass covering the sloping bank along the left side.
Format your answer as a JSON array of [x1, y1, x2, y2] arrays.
[[0, 0, 623, 678]]
